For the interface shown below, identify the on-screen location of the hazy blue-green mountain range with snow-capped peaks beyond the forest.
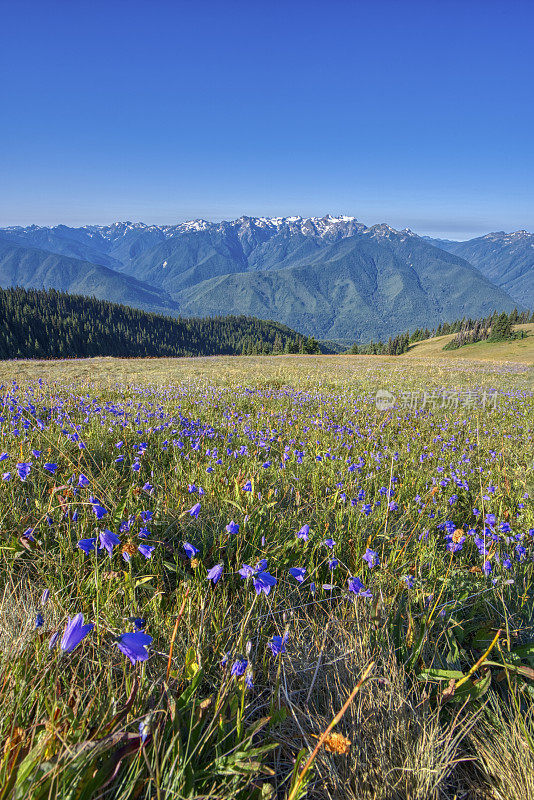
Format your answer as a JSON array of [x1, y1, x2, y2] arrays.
[[0, 215, 534, 344]]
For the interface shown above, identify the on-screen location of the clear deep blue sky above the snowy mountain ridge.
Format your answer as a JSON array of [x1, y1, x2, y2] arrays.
[[0, 0, 534, 238]]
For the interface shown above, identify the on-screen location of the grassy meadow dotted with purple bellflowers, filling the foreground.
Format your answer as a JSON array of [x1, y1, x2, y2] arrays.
[[0, 352, 534, 800]]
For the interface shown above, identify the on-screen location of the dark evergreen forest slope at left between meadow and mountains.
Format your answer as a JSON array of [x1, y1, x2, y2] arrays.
[[0, 287, 321, 359]]
